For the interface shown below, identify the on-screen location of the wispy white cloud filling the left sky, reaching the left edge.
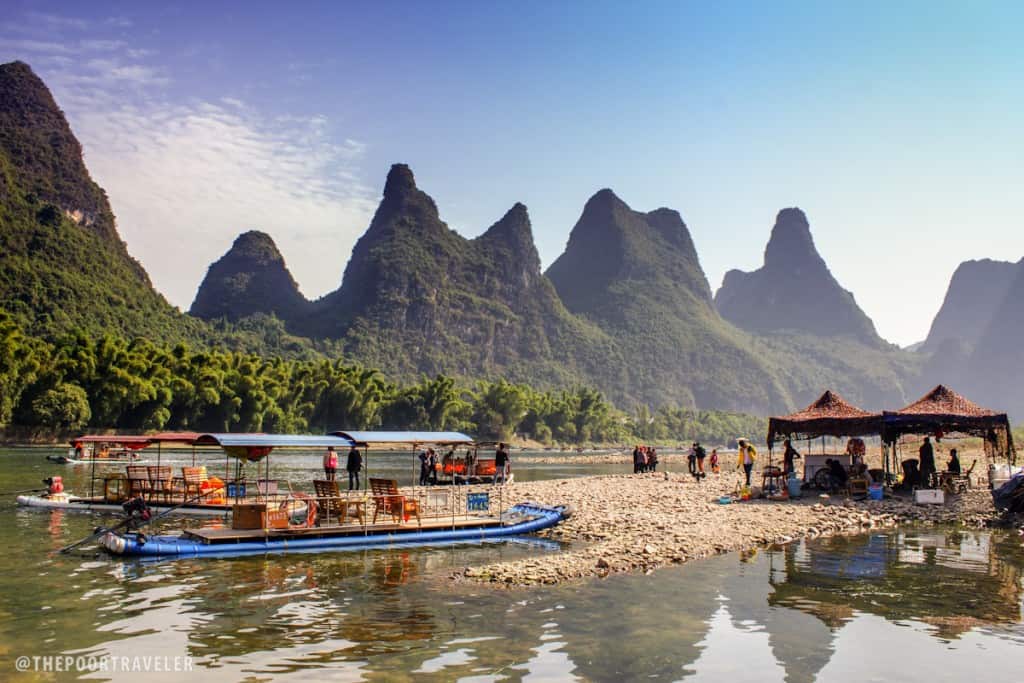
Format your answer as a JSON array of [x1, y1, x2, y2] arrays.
[[0, 6, 376, 308]]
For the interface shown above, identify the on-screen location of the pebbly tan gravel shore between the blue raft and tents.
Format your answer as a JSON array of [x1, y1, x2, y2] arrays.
[[453, 472, 998, 587]]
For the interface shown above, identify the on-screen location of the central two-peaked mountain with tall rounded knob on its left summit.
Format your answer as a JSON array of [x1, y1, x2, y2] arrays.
[[296, 164, 622, 391]]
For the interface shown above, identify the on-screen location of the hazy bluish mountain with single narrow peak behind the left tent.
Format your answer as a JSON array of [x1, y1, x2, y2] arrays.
[[715, 208, 887, 348]]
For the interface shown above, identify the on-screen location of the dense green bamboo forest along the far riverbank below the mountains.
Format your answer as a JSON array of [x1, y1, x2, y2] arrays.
[[0, 312, 765, 444]]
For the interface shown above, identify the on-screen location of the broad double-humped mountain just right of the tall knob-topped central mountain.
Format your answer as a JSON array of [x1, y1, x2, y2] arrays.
[[548, 189, 790, 412]]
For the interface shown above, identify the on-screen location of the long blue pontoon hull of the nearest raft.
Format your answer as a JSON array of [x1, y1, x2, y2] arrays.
[[99, 503, 571, 557]]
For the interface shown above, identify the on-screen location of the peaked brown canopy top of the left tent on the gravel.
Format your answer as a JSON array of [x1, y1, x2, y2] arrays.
[[768, 390, 882, 449]]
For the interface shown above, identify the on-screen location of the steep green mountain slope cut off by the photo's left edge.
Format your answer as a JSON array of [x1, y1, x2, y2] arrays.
[[0, 61, 203, 340]]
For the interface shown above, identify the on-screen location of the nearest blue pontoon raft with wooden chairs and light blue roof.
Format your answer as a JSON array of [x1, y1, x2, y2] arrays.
[[99, 432, 571, 558]]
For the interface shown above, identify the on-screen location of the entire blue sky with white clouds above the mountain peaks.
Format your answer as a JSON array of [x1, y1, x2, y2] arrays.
[[0, 0, 1024, 344]]
